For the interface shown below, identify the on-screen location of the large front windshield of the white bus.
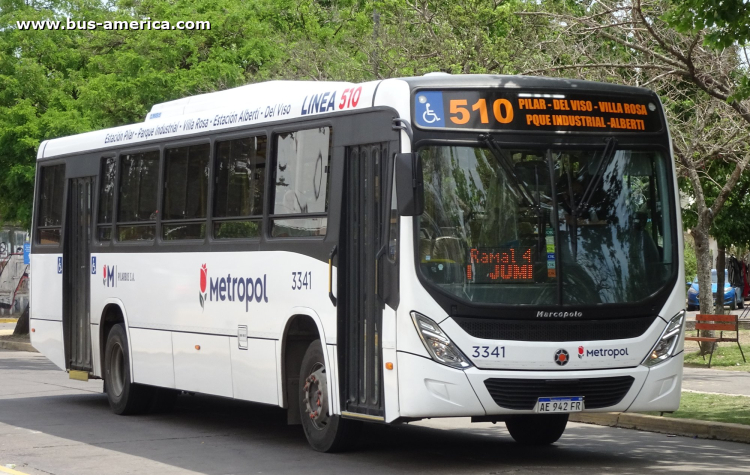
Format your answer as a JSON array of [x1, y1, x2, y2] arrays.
[[418, 142, 676, 305]]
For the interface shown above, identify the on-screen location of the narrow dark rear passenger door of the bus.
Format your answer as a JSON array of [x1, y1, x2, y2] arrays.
[[63, 177, 95, 372]]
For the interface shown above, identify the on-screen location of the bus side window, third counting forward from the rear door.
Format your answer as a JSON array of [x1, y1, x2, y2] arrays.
[[161, 143, 211, 241]]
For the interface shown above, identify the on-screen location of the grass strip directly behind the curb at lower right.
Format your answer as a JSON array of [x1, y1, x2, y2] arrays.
[[644, 392, 750, 425]]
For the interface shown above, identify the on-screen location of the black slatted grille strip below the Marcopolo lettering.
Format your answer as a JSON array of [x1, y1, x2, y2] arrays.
[[453, 317, 657, 342]]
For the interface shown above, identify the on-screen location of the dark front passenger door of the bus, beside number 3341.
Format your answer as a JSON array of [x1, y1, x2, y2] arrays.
[[338, 142, 394, 420]]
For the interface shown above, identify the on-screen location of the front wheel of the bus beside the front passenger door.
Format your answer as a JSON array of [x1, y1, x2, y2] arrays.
[[299, 340, 362, 452]]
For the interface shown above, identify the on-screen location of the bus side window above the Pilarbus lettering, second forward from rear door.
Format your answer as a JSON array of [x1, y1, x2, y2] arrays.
[[117, 150, 159, 241]]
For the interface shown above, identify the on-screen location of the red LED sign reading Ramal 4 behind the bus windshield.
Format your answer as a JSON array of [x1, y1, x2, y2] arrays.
[[466, 247, 535, 284]]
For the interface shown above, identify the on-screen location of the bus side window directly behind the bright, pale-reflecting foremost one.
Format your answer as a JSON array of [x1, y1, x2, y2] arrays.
[[213, 135, 268, 239]]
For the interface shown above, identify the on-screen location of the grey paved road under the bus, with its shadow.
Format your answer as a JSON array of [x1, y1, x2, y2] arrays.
[[0, 350, 750, 475]]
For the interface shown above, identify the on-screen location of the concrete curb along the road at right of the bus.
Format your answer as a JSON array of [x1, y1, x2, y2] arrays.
[[569, 412, 750, 444]]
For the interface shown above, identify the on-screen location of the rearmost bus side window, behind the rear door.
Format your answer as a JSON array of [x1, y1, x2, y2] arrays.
[[36, 165, 65, 245]]
